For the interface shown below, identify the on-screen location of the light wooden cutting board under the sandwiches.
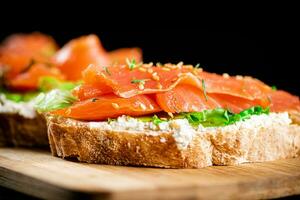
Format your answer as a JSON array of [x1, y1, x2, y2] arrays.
[[0, 148, 300, 199]]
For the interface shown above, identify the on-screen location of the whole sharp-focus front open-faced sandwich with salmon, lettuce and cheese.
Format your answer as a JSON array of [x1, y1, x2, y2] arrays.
[[35, 60, 300, 168]]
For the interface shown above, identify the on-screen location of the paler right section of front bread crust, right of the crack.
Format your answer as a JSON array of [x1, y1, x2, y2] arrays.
[[211, 124, 300, 165]]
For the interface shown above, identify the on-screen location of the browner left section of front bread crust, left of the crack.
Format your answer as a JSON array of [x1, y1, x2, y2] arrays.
[[48, 116, 212, 168]]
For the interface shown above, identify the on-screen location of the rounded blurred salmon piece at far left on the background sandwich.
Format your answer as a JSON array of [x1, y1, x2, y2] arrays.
[[0, 32, 58, 79]]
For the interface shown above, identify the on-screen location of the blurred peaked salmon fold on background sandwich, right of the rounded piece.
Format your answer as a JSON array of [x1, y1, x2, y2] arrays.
[[53, 35, 142, 81]]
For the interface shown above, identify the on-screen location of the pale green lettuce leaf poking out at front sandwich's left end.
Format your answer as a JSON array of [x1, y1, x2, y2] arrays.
[[34, 89, 77, 112]]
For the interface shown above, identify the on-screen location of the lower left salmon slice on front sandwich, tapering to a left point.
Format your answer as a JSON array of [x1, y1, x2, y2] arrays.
[[52, 94, 161, 120]]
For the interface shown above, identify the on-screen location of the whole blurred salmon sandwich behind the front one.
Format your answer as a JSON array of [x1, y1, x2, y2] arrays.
[[0, 33, 142, 146]]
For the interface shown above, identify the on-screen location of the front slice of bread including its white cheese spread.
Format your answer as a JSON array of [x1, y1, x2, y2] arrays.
[[46, 113, 300, 168]]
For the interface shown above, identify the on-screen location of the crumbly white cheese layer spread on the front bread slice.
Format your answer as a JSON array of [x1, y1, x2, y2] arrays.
[[89, 112, 291, 149]]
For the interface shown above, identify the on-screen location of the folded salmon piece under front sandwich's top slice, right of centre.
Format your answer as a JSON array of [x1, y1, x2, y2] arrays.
[[156, 85, 270, 113]]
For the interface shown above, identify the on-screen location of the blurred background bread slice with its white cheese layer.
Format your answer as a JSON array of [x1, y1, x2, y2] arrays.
[[0, 94, 49, 148]]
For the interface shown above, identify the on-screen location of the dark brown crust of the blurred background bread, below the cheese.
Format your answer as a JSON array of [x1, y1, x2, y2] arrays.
[[0, 113, 49, 147]]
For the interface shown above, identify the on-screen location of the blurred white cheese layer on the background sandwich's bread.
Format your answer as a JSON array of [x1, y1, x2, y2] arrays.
[[0, 94, 36, 119]]
